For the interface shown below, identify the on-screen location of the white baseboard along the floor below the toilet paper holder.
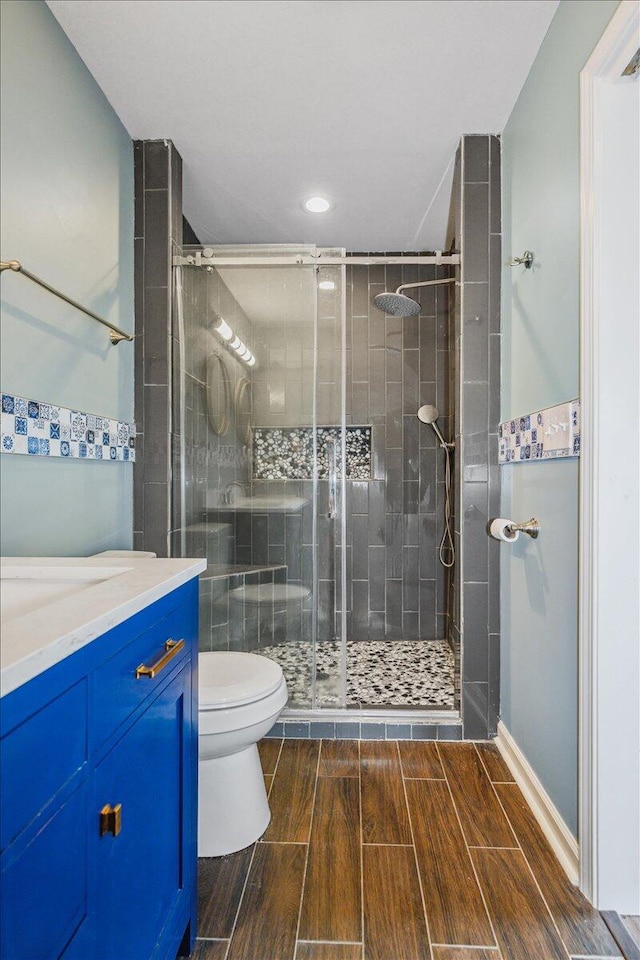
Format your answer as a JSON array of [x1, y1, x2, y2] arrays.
[[495, 720, 580, 884]]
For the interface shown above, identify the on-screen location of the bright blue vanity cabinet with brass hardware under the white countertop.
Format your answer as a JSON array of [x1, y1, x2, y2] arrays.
[[0, 580, 198, 960]]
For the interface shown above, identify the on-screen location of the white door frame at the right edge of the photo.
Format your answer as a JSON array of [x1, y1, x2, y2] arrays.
[[579, 0, 640, 913]]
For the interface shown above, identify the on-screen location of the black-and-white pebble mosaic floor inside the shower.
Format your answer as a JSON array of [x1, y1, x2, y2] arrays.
[[255, 640, 455, 710]]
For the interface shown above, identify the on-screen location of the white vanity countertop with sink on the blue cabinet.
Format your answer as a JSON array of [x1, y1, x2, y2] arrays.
[[0, 553, 206, 697]]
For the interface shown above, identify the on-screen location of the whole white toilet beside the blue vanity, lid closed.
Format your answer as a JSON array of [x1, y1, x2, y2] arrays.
[[198, 652, 287, 857]]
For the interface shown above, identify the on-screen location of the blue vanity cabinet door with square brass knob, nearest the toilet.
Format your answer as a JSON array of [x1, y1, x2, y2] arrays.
[[89, 665, 192, 960]]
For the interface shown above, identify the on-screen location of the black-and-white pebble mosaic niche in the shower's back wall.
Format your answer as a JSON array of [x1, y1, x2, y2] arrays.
[[253, 427, 371, 480]]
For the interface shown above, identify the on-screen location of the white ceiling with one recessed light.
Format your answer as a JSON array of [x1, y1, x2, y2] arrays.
[[47, 0, 558, 251]]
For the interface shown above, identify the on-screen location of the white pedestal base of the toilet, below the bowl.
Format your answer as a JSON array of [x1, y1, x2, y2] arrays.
[[198, 743, 271, 857]]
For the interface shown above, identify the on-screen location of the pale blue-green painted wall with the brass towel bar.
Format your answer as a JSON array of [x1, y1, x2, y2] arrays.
[[0, 0, 133, 555]]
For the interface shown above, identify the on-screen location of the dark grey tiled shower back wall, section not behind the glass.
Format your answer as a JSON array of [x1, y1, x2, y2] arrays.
[[342, 265, 451, 641]]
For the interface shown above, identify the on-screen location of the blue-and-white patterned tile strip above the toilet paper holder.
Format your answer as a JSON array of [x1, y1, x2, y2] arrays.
[[498, 400, 580, 463]]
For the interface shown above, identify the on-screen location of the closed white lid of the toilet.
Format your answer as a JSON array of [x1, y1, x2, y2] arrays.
[[198, 652, 283, 710]]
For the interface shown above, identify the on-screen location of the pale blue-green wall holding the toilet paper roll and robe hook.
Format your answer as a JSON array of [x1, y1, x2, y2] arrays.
[[501, 0, 618, 833]]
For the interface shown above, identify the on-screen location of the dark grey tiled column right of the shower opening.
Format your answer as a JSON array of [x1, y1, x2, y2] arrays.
[[448, 136, 501, 739]]
